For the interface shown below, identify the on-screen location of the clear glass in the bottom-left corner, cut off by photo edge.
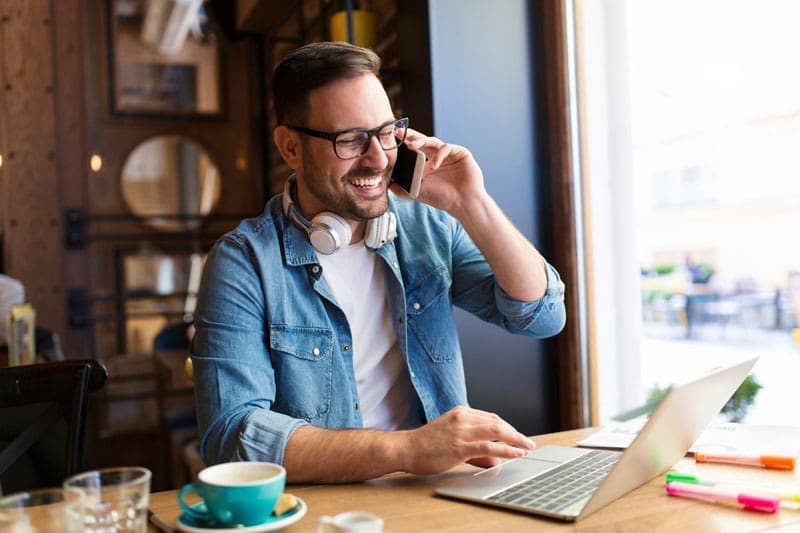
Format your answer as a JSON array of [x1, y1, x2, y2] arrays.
[[0, 487, 84, 533]]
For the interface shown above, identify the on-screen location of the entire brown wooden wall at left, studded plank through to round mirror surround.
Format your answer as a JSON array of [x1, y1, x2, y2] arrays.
[[0, 0, 267, 357]]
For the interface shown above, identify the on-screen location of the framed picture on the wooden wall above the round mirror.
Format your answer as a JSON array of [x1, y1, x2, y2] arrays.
[[108, 0, 223, 116]]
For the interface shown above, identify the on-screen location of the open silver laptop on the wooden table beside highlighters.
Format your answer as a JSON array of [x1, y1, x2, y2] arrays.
[[435, 357, 758, 521]]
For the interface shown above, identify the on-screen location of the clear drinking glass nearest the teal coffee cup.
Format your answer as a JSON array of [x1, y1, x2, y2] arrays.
[[64, 467, 151, 533]]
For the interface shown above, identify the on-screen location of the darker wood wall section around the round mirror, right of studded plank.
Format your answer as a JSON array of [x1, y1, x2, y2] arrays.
[[84, 0, 267, 356]]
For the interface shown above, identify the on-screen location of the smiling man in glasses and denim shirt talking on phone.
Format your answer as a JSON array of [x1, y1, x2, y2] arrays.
[[192, 43, 565, 482]]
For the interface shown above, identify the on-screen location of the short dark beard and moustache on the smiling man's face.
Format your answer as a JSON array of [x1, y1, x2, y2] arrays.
[[302, 145, 392, 220]]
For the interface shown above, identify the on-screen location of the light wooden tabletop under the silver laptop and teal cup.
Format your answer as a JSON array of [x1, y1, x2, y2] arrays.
[[150, 429, 800, 533]]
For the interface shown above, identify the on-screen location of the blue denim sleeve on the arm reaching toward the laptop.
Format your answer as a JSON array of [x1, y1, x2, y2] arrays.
[[191, 237, 305, 464]]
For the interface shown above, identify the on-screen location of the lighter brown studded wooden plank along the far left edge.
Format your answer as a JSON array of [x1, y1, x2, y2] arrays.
[[0, 0, 72, 354]]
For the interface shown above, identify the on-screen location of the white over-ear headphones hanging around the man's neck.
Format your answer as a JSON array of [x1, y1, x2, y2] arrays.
[[283, 176, 397, 255]]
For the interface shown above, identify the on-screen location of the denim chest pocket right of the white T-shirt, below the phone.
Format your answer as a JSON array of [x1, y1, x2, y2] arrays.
[[406, 266, 459, 363]]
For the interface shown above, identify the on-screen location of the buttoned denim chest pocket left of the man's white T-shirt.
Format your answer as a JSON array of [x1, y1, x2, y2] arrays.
[[269, 325, 333, 422]]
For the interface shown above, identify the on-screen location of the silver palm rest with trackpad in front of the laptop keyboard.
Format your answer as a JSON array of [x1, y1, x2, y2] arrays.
[[436, 456, 560, 499]]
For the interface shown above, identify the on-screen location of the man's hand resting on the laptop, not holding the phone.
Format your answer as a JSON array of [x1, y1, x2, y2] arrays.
[[404, 406, 536, 475]]
